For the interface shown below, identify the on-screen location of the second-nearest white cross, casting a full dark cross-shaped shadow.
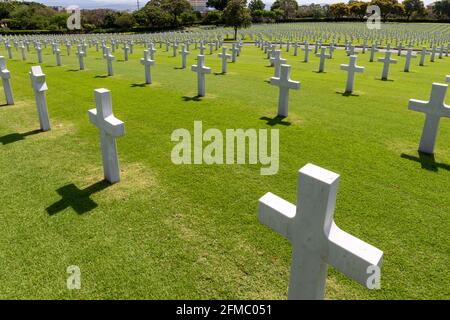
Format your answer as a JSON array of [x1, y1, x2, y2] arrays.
[[88, 89, 125, 183]]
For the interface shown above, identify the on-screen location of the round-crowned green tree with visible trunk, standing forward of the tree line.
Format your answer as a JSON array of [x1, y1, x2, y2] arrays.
[[222, 0, 252, 40]]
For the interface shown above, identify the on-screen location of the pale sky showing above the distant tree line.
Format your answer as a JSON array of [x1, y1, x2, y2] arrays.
[[34, 0, 434, 10]]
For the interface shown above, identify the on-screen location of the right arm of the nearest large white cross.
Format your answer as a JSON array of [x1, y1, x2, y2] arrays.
[[328, 222, 383, 287]]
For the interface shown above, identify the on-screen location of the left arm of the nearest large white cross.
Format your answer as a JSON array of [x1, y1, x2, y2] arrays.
[[258, 192, 296, 240]]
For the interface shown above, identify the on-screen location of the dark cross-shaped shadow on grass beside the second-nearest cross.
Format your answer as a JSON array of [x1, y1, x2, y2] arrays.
[[45, 180, 111, 216]]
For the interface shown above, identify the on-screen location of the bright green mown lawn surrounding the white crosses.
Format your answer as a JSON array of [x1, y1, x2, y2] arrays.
[[0, 45, 450, 299]]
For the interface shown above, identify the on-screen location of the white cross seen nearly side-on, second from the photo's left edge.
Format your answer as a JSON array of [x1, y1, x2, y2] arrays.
[[30, 66, 50, 131]]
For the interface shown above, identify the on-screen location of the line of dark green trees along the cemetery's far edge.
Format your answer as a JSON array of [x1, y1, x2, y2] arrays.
[[0, 0, 450, 32]]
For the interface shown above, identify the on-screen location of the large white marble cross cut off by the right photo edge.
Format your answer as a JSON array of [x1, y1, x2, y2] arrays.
[[408, 83, 450, 154]]
